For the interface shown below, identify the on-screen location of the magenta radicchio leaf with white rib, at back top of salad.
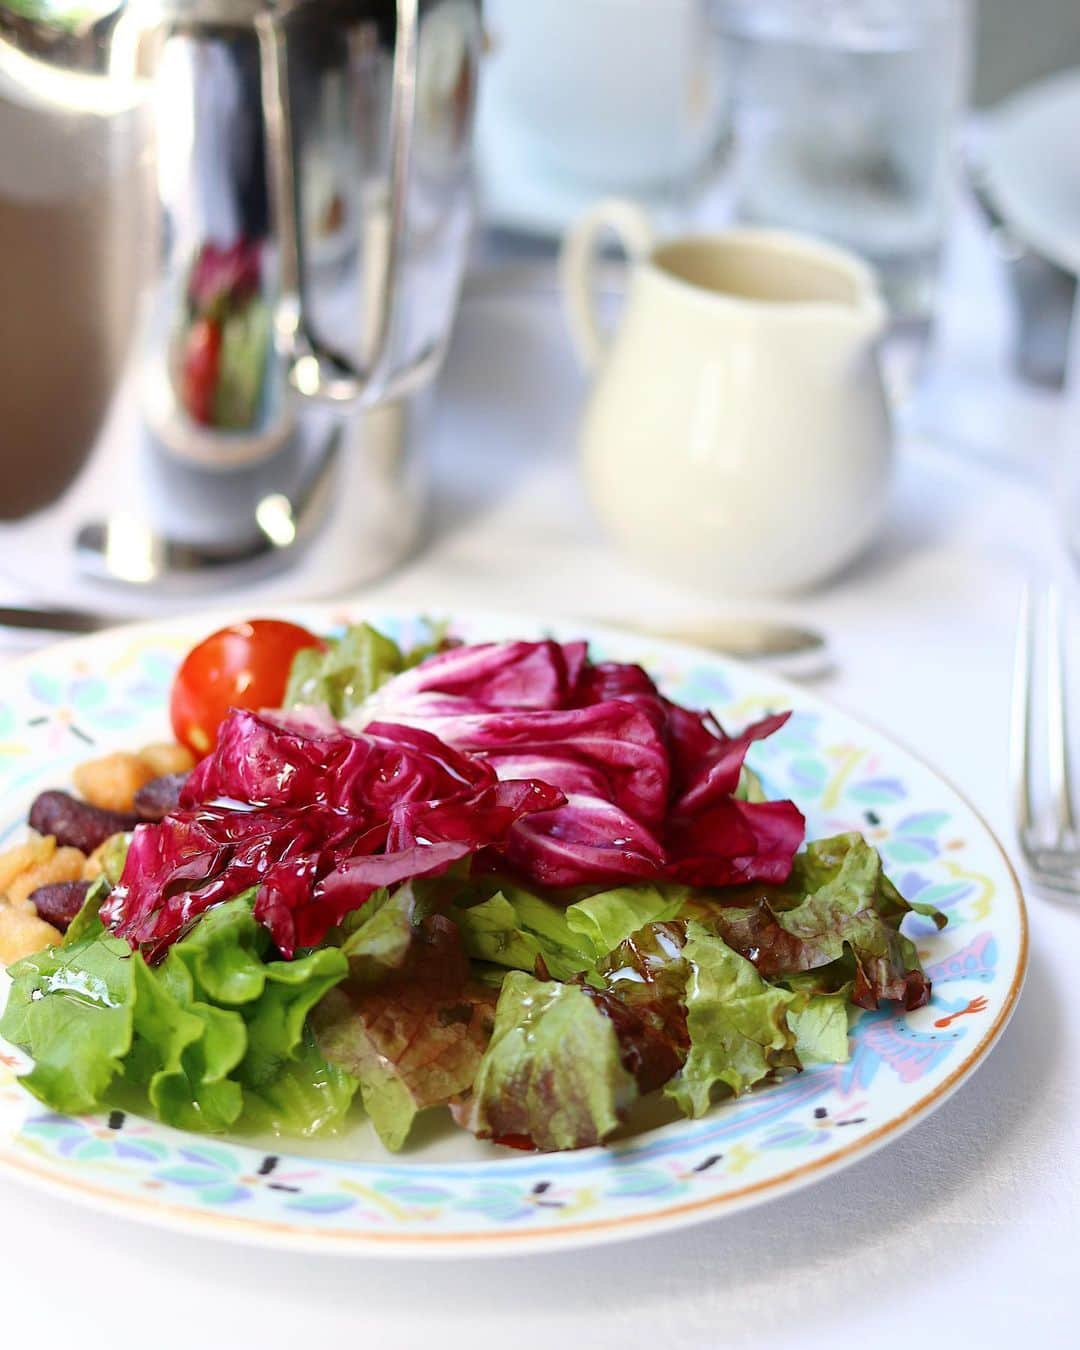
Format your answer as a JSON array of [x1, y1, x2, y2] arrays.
[[356, 641, 805, 887]]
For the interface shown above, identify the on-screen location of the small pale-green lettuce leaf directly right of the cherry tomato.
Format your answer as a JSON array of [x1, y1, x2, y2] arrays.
[[285, 624, 446, 718]]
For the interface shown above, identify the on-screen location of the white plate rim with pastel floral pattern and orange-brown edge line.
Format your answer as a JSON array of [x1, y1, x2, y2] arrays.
[[0, 605, 1027, 1257]]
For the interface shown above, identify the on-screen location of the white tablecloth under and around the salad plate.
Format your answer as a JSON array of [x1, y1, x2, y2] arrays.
[[0, 205, 1080, 1350]]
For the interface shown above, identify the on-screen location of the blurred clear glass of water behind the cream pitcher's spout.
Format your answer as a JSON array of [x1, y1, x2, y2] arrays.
[[720, 0, 972, 320]]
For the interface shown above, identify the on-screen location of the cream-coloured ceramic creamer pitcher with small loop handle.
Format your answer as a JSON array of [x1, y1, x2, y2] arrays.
[[562, 201, 891, 595]]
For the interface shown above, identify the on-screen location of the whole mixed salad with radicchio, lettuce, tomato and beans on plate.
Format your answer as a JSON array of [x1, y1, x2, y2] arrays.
[[0, 620, 945, 1150]]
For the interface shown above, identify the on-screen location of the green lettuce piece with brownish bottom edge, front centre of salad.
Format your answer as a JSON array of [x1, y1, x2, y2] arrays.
[[455, 971, 636, 1149]]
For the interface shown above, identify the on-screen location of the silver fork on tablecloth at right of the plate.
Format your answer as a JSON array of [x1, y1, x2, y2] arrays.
[[1010, 586, 1080, 899]]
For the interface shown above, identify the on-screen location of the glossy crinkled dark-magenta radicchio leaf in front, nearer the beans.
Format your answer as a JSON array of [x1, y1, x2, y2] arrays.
[[101, 711, 563, 959]]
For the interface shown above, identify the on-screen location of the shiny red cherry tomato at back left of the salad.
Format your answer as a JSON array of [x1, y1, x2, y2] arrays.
[[169, 618, 327, 757]]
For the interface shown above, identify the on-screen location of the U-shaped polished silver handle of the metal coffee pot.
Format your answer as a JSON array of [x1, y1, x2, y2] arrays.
[[257, 0, 420, 404]]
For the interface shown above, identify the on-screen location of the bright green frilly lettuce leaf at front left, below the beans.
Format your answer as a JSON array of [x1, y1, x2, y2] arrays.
[[0, 883, 356, 1134]]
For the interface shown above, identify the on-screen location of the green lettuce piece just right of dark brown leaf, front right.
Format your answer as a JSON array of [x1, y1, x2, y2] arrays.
[[664, 919, 795, 1116]]
